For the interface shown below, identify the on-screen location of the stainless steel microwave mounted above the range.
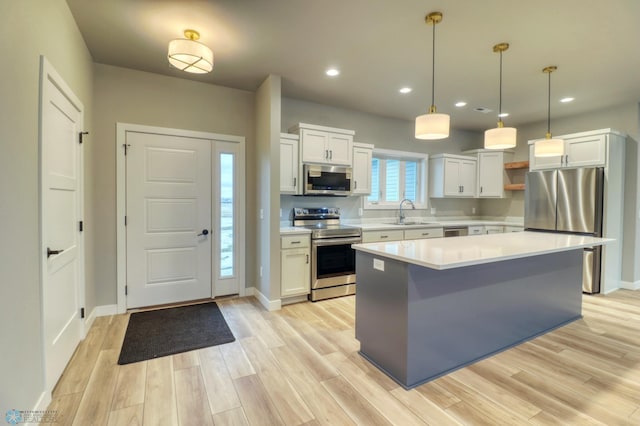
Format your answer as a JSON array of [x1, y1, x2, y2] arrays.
[[302, 164, 353, 196]]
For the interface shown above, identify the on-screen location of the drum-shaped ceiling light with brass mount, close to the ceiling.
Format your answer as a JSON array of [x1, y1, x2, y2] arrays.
[[167, 30, 213, 74]]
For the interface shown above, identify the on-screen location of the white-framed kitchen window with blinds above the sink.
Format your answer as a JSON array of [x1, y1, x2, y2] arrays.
[[365, 150, 427, 209]]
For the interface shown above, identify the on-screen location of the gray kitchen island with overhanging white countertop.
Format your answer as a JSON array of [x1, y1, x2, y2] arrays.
[[353, 232, 613, 389]]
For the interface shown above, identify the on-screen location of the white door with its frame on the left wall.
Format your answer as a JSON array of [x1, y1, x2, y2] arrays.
[[40, 57, 84, 391]]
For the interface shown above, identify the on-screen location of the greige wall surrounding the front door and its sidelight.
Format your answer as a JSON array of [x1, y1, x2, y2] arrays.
[[93, 64, 256, 305]]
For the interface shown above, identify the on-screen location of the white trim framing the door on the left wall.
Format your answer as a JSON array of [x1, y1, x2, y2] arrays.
[[38, 55, 86, 394]]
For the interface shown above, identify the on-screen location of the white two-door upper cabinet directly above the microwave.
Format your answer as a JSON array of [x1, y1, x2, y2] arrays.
[[289, 123, 355, 166]]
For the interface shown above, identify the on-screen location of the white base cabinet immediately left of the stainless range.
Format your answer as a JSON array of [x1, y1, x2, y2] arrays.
[[280, 234, 311, 297]]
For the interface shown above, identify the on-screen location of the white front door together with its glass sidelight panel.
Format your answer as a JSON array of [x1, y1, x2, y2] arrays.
[[126, 132, 241, 308]]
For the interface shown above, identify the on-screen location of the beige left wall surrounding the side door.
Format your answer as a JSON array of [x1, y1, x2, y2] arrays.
[[0, 0, 94, 416]]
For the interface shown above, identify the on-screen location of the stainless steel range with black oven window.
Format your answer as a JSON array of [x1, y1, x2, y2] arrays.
[[294, 207, 362, 302]]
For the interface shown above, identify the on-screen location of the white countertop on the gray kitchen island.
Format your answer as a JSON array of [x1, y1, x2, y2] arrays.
[[352, 232, 614, 269]]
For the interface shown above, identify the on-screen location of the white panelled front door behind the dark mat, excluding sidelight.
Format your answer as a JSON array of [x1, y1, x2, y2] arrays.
[[126, 132, 212, 308]]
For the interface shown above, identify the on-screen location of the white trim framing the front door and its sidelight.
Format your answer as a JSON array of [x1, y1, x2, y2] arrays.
[[115, 123, 246, 313]]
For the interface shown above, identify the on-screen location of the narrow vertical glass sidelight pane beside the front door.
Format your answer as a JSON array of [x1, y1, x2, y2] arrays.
[[219, 153, 235, 278]]
